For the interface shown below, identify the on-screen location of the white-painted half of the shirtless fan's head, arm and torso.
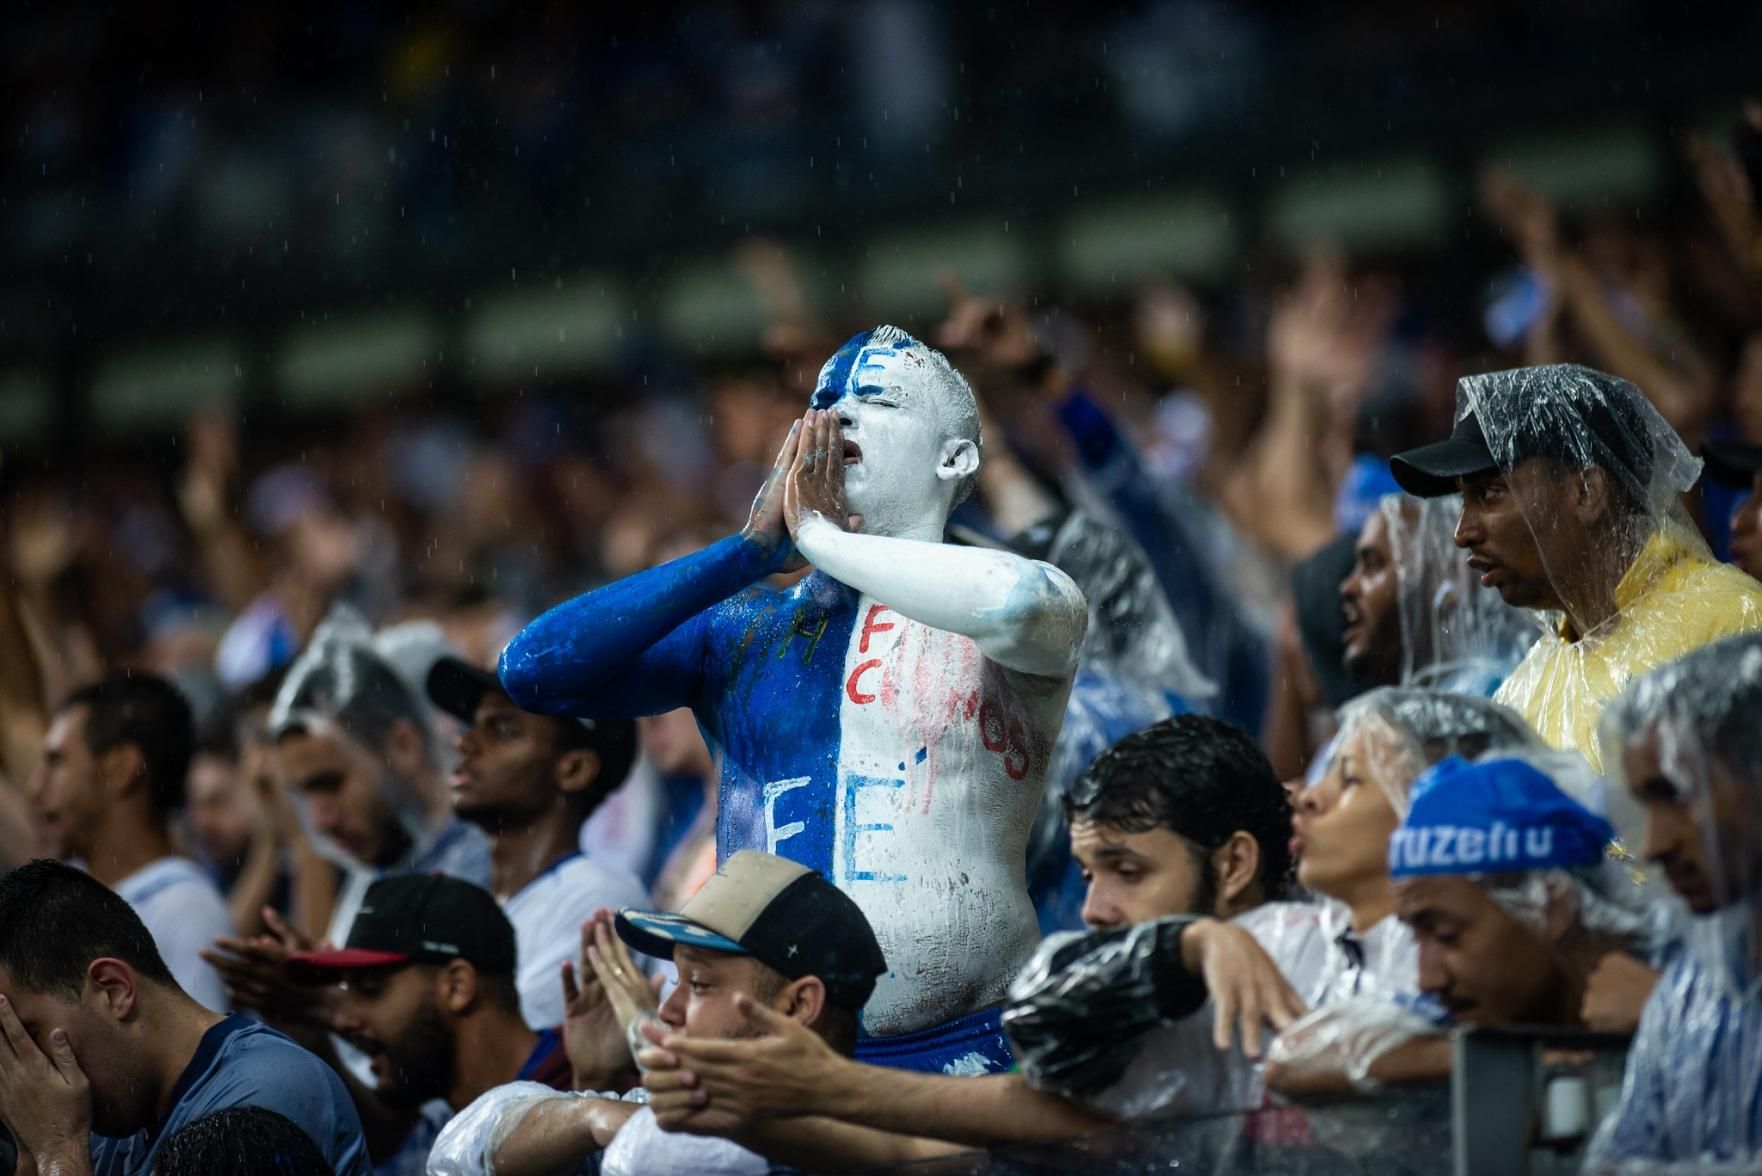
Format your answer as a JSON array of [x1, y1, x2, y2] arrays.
[[785, 328, 1089, 1037]]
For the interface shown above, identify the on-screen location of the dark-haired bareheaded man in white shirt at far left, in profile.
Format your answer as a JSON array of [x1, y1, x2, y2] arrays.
[[33, 674, 233, 1012]]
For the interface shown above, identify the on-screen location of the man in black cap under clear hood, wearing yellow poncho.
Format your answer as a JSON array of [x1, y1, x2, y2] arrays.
[[1390, 363, 1762, 769]]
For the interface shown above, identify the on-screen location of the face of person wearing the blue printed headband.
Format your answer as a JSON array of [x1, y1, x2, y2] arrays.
[[1394, 876, 1565, 1024]]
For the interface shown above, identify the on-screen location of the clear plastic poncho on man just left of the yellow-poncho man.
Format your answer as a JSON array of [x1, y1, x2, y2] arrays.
[[1378, 494, 1535, 696]]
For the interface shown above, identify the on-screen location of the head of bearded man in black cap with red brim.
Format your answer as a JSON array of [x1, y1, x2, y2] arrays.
[[287, 875, 569, 1163]]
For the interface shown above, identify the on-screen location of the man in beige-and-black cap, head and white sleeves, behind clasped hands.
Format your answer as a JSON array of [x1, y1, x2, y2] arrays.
[[430, 850, 886, 1176]]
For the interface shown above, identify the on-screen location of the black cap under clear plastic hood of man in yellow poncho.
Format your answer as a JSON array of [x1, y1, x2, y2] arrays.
[[1388, 363, 1651, 499]]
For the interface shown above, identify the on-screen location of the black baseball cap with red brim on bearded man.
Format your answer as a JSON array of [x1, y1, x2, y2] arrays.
[[287, 875, 518, 984]]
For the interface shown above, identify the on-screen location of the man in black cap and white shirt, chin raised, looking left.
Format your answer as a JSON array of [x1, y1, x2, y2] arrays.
[[428, 658, 647, 1028]]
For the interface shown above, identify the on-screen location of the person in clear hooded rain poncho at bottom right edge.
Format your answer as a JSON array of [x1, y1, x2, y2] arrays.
[[1588, 635, 1762, 1172]]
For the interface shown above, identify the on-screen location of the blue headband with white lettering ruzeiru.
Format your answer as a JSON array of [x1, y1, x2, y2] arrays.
[[1388, 756, 1616, 878]]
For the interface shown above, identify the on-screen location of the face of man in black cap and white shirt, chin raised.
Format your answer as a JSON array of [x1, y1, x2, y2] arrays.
[[451, 691, 559, 825]]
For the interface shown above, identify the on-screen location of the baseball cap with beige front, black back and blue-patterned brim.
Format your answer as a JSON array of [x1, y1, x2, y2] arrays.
[[617, 850, 886, 1012]]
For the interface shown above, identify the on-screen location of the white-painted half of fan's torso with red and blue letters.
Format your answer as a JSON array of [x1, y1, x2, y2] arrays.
[[806, 596, 1071, 1035]]
